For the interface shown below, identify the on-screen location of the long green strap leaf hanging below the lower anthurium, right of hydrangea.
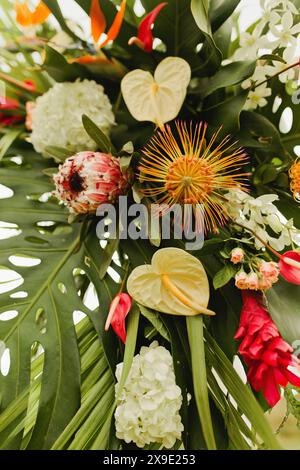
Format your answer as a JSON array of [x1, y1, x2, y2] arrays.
[[186, 315, 217, 450]]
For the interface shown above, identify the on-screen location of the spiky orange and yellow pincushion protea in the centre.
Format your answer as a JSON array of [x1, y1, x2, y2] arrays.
[[139, 121, 248, 233]]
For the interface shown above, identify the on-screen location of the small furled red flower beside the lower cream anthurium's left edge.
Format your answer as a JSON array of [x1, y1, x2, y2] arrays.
[[105, 293, 132, 343]]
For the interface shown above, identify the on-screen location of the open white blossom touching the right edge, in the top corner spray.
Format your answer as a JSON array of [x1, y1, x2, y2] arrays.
[[270, 11, 300, 47]]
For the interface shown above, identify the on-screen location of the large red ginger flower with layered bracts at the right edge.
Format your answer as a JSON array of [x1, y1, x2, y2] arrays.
[[235, 291, 300, 407]]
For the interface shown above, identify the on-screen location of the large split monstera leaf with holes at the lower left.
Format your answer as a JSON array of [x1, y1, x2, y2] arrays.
[[0, 152, 118, 449]]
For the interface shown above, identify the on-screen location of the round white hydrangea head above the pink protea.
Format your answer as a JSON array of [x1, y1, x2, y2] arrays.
[[31, 80, 115, 154]]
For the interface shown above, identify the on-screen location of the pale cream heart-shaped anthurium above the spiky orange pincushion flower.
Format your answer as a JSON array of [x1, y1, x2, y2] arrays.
[[121, 57, 191, 128]]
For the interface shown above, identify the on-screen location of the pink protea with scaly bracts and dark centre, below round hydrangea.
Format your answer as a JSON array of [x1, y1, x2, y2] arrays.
[[53, 152, 130, 214]]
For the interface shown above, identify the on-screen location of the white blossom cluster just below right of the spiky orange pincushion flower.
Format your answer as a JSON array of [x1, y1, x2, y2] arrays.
[[225, 190, 300, 251]]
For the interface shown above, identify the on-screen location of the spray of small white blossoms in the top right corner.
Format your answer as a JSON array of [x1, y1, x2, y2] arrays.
[[233, 0, 300, 110]]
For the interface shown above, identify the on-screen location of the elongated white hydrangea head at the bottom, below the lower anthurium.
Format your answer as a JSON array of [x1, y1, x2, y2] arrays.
[[115, 341, 183, 449]]
